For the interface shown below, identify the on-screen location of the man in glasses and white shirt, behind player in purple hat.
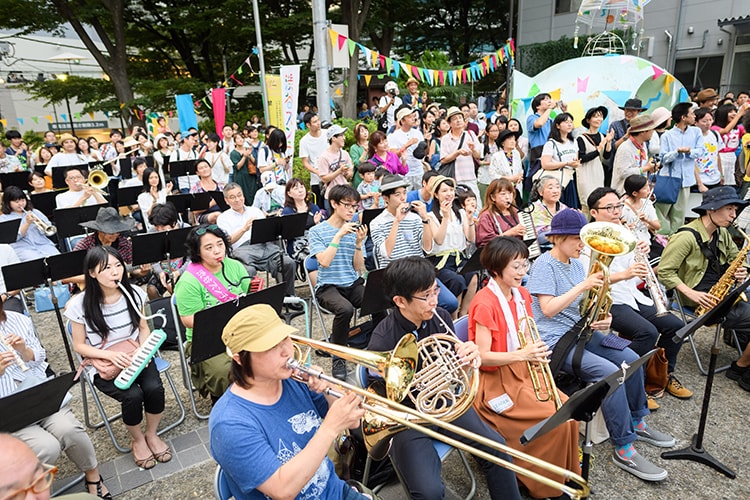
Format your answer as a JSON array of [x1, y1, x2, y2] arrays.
[[592, 187, 693, 411]]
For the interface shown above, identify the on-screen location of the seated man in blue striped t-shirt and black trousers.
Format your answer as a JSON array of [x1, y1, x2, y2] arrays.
[[308, 184, 367, 380]]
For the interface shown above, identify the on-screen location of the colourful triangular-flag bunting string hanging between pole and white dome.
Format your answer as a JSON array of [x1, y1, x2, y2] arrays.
[[328, 28, 516, 87]]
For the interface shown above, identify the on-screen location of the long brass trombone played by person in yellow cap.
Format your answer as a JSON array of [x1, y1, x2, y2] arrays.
[[287, 335, 589, 499]]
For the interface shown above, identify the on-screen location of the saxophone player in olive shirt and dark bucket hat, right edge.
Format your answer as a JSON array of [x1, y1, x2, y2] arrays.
[[659, 186, 750, 391]]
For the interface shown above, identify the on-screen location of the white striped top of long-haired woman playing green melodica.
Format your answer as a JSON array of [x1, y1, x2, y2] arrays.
[[65, 287, 146, 348]]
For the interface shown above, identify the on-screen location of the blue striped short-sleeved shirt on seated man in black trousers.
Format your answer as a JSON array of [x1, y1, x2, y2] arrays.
[[308, 221, 359, 290]]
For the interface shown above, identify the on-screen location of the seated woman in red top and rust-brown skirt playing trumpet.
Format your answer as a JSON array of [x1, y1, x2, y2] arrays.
[[469, 236, 580, 498]]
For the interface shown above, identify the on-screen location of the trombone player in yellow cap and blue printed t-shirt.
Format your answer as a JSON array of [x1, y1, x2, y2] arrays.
[[208, 304, 372, 500]]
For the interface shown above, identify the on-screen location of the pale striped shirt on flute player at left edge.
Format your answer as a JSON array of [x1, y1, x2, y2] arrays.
[[0, 311, 47, 398]]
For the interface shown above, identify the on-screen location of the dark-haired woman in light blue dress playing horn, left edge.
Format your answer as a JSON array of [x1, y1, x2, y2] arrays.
[[0, 186, 60, 262]]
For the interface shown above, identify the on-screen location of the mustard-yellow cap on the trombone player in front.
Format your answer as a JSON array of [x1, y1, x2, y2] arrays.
[[221, 304, 297, 356]]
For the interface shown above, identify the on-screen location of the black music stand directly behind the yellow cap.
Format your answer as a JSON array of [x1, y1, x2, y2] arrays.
[[190, 283, 284, 364]]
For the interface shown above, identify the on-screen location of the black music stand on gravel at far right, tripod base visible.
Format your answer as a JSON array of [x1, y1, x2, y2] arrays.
[[661, 280, 750, 479]]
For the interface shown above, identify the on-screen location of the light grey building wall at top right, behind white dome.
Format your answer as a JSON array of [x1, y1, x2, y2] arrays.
[[516, 0, 750, 92]]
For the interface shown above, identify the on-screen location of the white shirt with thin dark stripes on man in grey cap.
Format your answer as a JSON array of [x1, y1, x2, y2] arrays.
[[370, 210, 424, 269]]
